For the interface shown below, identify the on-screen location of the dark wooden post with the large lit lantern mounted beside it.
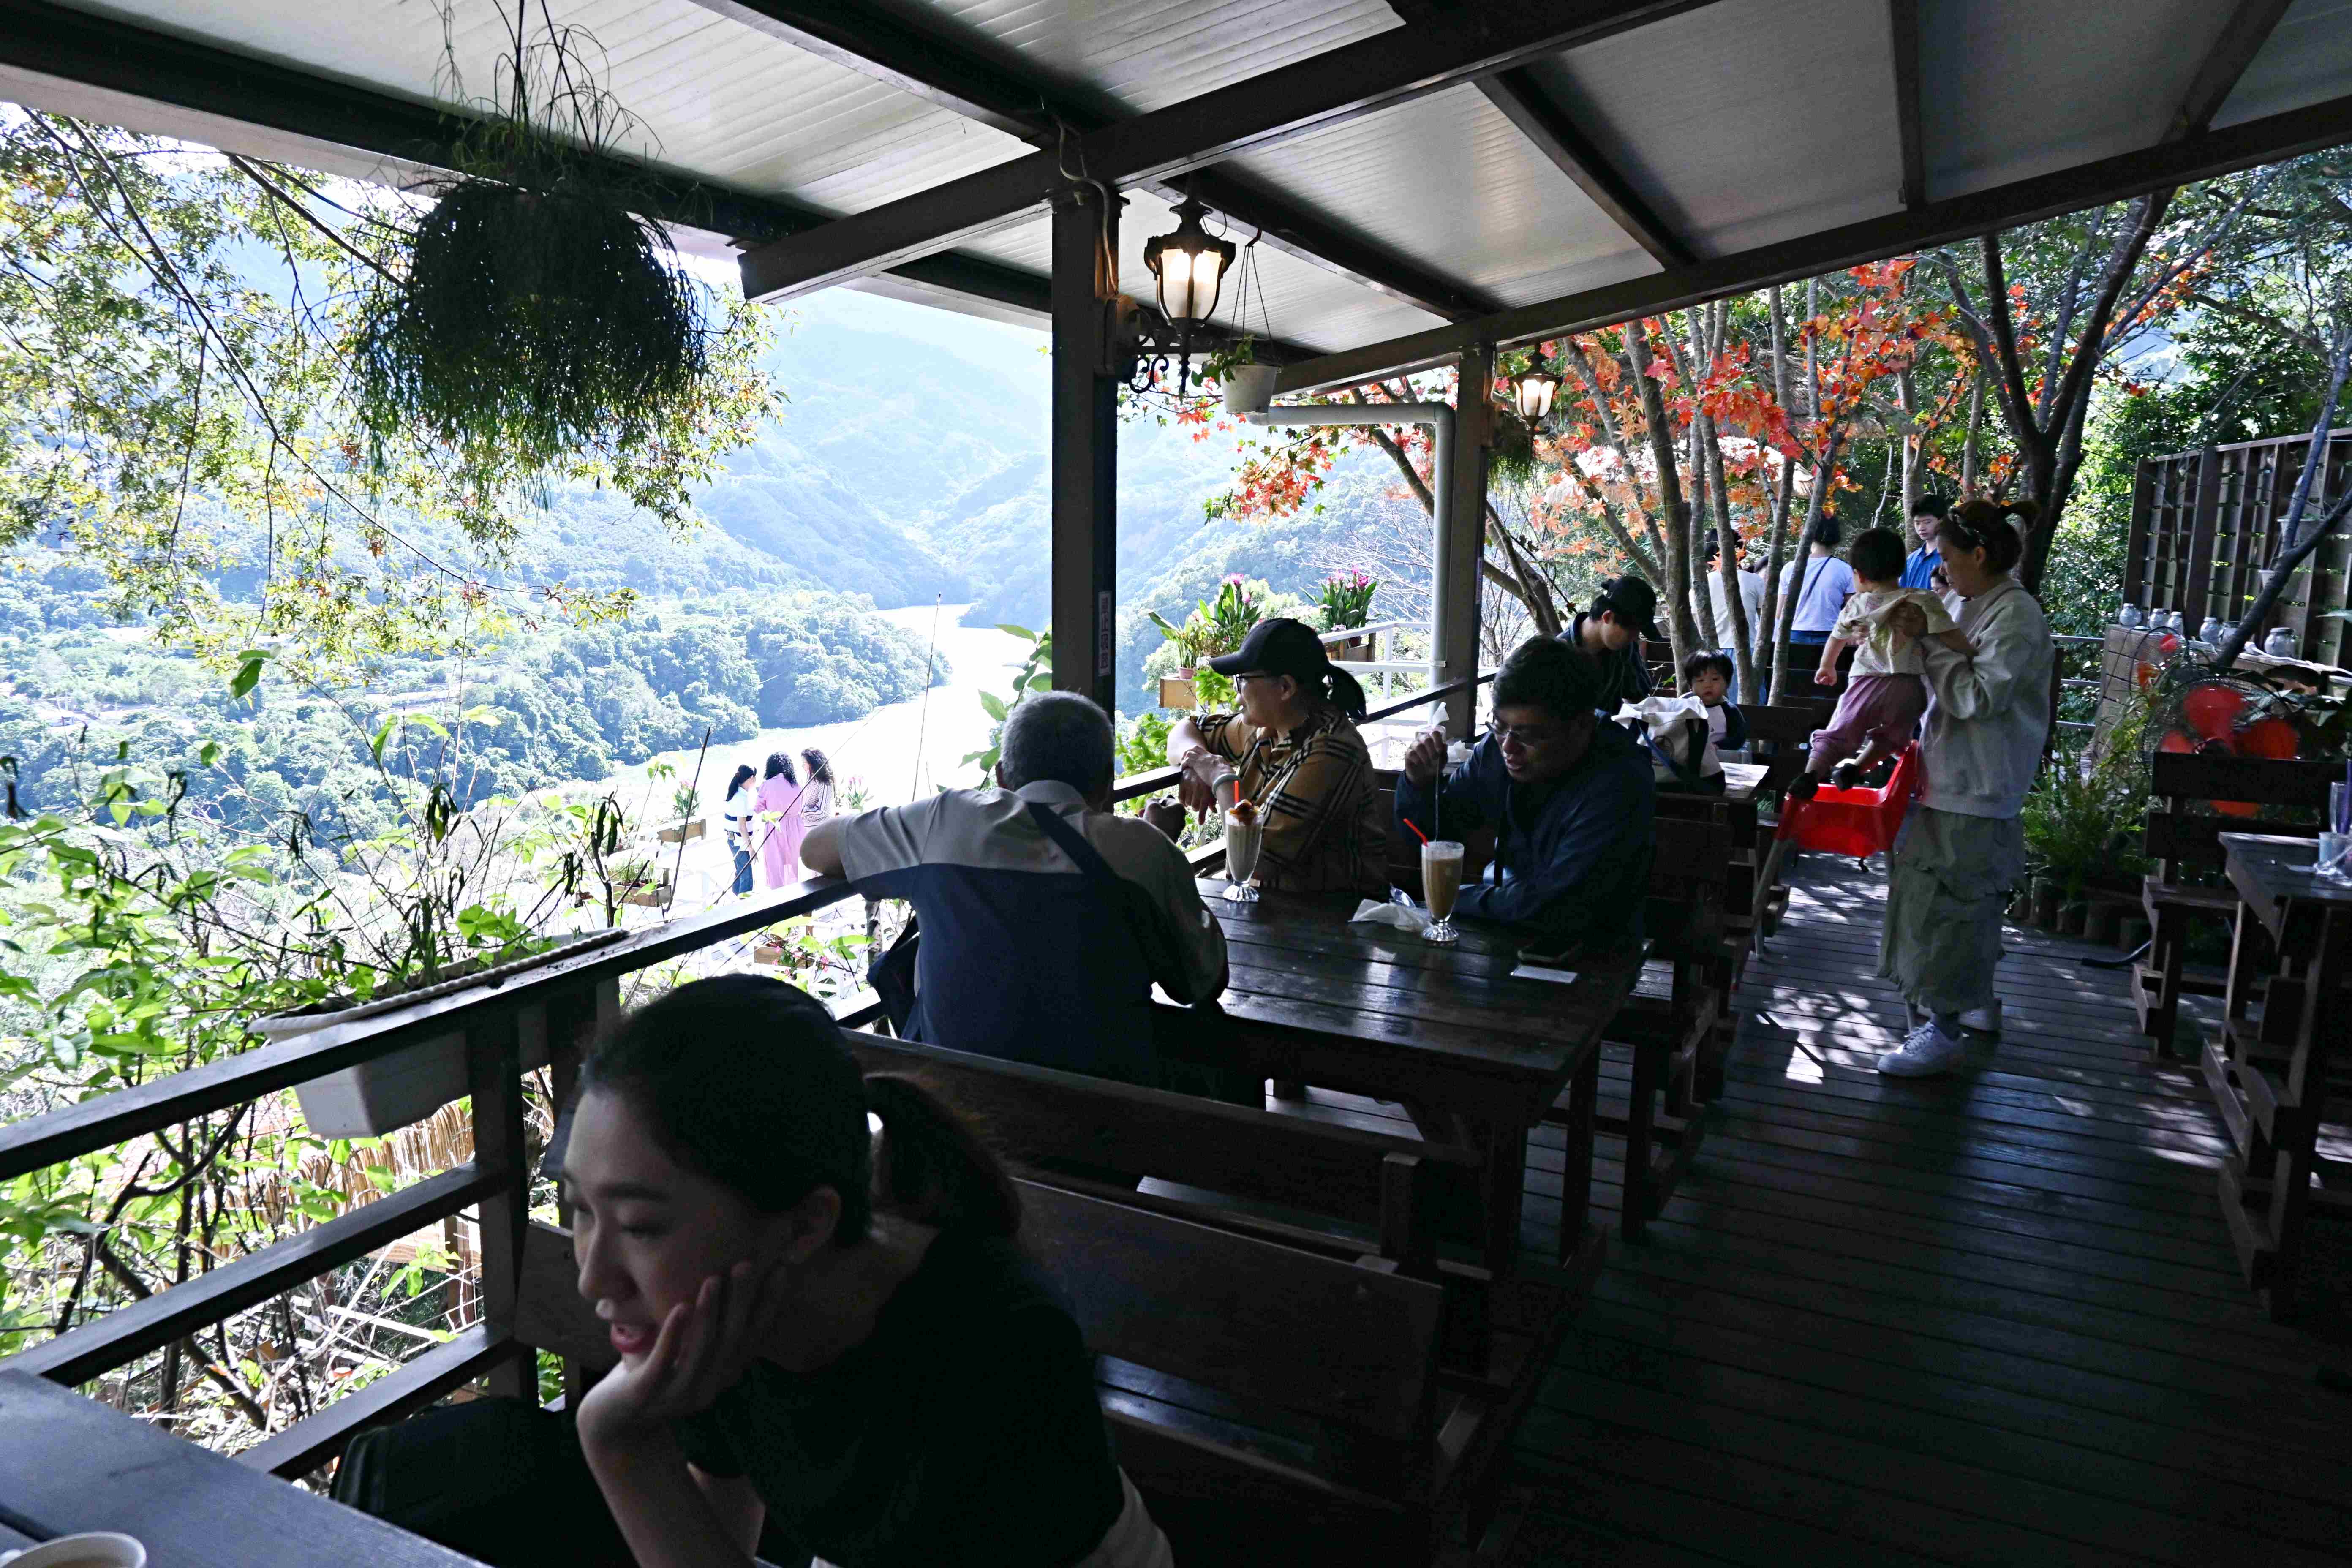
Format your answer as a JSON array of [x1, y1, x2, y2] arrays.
[[1051, 186, 1119, 712]]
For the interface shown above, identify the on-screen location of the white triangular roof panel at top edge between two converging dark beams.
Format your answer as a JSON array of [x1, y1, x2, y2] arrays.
[[908, 0, 1404, 113]]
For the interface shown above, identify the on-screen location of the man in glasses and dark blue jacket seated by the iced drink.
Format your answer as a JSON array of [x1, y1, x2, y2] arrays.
[[1397, 637, 1656, 952]]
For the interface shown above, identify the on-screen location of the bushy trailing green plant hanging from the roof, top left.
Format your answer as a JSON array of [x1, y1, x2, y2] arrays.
[[353, 0, 710, 484]]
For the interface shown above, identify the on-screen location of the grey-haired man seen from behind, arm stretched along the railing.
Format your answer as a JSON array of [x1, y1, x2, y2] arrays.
[[800, 691, 1225, 1084]]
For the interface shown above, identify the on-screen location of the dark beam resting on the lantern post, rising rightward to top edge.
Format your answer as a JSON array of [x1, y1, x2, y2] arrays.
[[743, 0, 1710, 299]]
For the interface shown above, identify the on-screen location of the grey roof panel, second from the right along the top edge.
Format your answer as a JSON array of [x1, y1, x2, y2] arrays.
[[1919, 0, 2237, 197]]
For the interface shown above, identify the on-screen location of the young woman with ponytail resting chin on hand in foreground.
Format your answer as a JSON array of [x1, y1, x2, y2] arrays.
[[562, 976, 1169, 1568]]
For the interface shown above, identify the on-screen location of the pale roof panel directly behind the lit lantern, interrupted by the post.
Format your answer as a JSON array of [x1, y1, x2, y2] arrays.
[[962, 191, 1440, 350]]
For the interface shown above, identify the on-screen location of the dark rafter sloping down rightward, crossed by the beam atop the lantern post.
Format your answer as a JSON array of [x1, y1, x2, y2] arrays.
[[694, 0, 1496, 322]]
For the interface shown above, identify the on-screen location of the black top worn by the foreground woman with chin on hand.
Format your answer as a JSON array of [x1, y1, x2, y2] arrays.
[[678, 1232, 1124, 1568]]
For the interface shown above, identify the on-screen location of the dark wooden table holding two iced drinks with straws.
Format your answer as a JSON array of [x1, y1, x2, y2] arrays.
[[1171, 879, 1642, 1277]]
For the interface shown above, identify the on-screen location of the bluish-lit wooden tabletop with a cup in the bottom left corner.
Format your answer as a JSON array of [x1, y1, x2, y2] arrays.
[[0, 1371, 473, 1568]]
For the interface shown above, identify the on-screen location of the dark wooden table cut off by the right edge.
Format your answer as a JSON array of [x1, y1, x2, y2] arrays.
[[2199, 832, 2352, 1319]]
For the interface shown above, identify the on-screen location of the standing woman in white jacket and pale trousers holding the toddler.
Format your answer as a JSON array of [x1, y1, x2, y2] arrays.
[[1879, 501, 2055, 1077]]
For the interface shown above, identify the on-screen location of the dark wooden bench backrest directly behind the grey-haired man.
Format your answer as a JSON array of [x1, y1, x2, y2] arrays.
[[849, 1032, 1477, 1265]]
